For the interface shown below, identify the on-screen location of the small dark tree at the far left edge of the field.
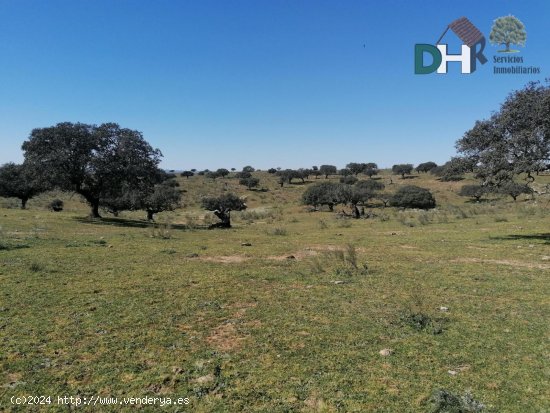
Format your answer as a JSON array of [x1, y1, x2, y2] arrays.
[[0, 163, 41, 209]]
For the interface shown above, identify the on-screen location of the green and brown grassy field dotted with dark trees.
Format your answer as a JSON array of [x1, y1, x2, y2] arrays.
[[0, 171, 550, 413]]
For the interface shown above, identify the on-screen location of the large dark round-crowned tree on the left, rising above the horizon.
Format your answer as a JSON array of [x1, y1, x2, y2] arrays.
[[23, 122, 162, 217]]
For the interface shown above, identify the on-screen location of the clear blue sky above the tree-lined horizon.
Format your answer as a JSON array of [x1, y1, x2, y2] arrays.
[[0, 0, 550, 170]]
